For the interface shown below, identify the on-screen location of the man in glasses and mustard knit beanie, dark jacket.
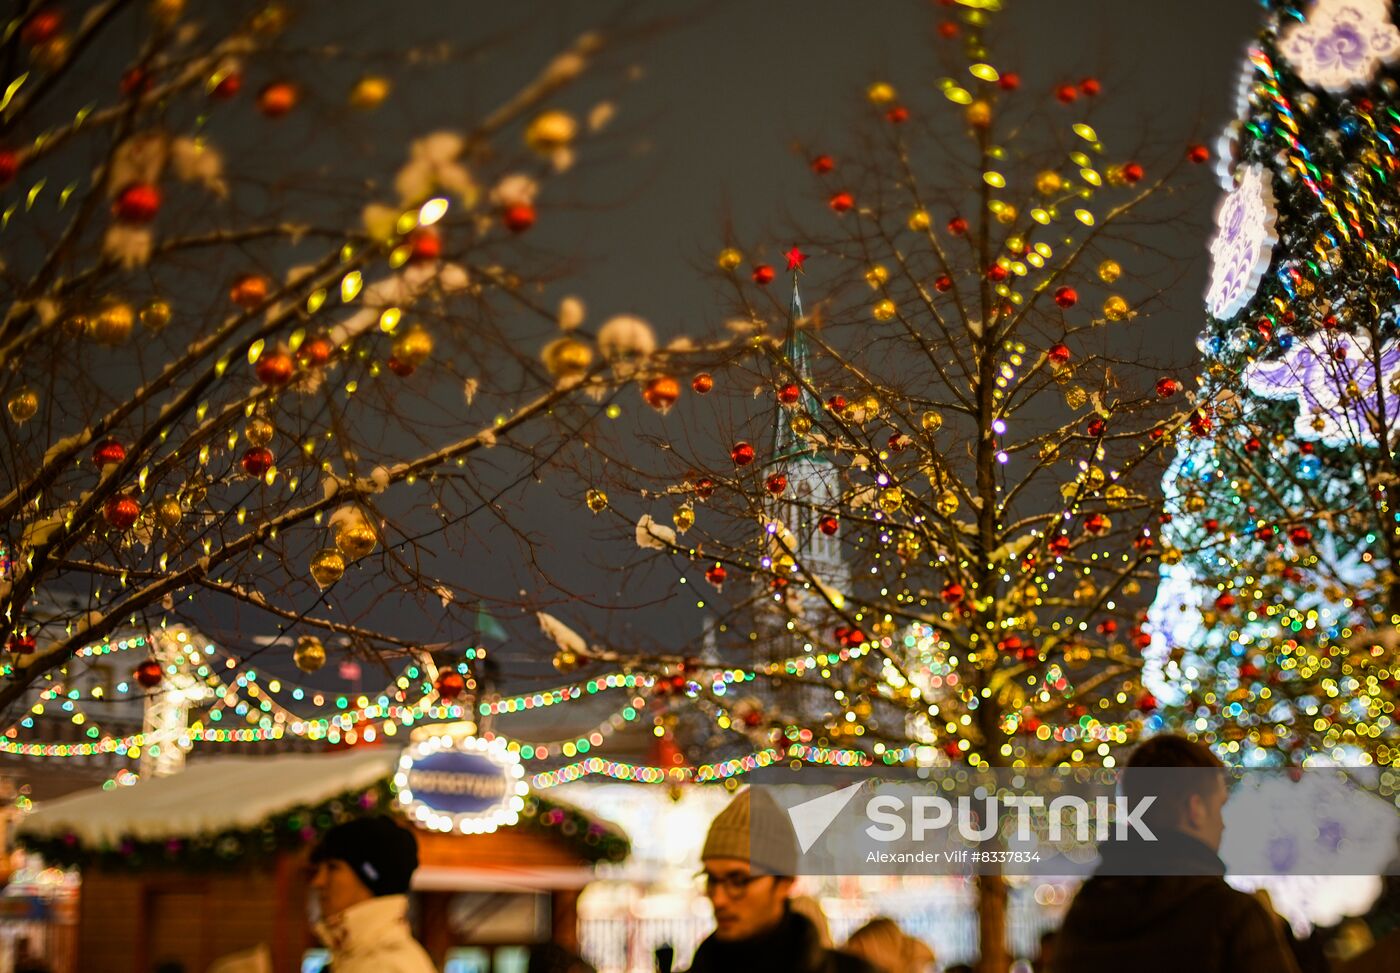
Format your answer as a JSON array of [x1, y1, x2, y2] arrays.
[[690, 788, 875, 973]]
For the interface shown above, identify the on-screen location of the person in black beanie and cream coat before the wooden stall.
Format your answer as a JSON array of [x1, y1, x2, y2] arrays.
[[311, 816, 437, 973]]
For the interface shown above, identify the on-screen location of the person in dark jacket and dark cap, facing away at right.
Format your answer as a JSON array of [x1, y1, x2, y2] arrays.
[[1050, 735, 1298, 973]]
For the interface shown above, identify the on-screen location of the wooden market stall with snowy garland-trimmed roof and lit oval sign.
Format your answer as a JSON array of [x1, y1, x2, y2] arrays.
[[20, 736, 629, 973]]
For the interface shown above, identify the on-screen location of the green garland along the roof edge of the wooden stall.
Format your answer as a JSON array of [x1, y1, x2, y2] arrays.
[[18, 778, 631, 872]]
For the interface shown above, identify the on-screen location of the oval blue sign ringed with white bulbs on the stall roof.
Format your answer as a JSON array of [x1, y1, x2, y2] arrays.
[[393, 734, 529, 834]]
